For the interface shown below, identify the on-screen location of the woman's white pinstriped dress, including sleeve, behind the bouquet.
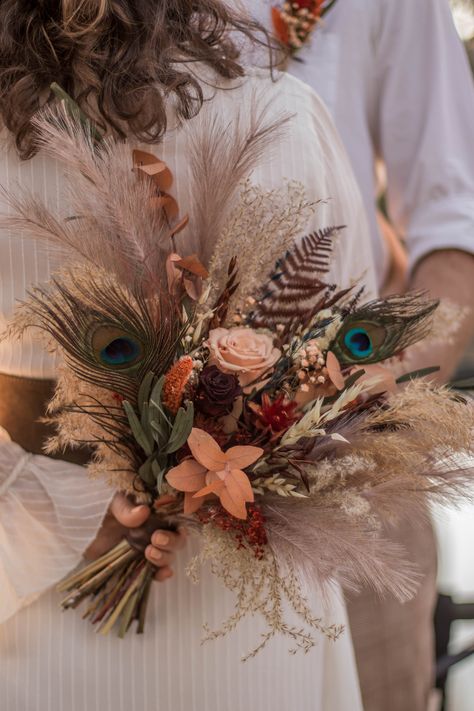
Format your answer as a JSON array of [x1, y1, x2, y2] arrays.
[[0, 68, 374, 711]]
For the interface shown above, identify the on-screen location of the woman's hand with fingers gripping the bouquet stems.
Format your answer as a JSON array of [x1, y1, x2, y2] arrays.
[[84, 494, 186, 582]]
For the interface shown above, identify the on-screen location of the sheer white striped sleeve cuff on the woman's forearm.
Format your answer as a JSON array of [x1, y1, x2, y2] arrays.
[[0, 442, 113, 622]]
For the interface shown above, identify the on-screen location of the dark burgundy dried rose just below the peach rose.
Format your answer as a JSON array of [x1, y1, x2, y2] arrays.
[[196, 365, 242, 417]]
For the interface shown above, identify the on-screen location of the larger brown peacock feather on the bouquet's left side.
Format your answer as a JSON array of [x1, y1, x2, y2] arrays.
[[19, 266, 183, 402]]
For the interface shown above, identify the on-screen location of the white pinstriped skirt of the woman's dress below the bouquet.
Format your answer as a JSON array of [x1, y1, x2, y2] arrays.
[[0, 542, 362, 711]]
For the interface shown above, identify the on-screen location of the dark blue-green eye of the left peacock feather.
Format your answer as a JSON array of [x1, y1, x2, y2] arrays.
[[91, 326, 143, 370]]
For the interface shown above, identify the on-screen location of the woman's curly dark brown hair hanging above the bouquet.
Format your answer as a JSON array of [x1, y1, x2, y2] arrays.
[[0, 0, 278, 159]]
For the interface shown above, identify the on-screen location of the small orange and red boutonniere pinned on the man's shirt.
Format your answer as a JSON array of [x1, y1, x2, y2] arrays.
[[272, 0, 336, 55]]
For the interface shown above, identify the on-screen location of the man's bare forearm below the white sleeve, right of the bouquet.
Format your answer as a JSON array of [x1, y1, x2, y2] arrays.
[[408, 249, 474, 382]]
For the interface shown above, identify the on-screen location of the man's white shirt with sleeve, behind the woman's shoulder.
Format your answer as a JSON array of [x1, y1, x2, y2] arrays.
[[246, 0, 474, 283]]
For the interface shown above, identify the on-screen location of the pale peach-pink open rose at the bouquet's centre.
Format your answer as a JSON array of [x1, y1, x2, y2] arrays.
[[207, 328, 281, 387]]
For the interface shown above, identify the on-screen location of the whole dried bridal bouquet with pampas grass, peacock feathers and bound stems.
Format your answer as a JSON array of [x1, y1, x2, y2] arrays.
[[2, 93, 473, 654]]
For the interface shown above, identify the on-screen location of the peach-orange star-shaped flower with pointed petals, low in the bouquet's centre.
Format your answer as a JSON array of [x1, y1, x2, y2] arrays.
[[166, 427, 263, 519]]
